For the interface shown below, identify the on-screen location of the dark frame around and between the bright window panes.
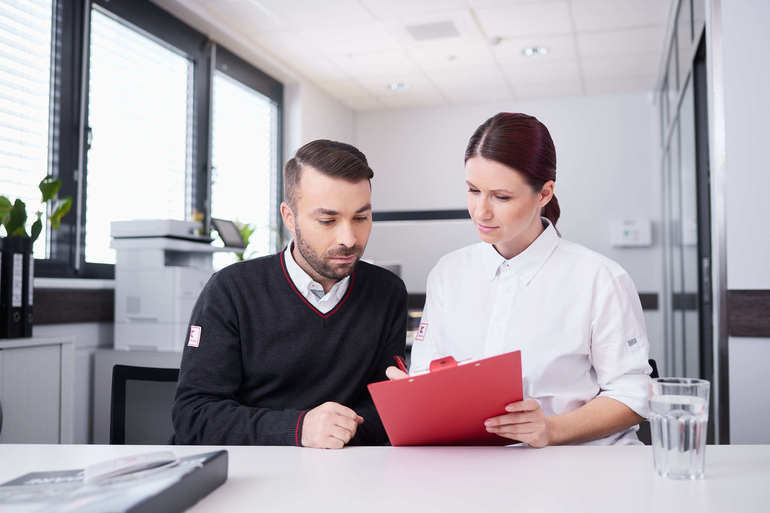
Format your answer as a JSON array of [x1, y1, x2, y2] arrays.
[[35, 0, 283, 279]]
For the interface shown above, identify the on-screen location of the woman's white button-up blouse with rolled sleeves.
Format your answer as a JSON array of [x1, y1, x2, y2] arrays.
[[410, 220, 651, 445]]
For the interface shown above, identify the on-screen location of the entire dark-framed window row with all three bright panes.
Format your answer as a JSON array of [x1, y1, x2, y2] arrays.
[[0, 0, 283, 278]]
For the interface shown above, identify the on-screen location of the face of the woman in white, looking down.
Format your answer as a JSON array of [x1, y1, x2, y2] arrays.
[[465, 156, 554, 258]]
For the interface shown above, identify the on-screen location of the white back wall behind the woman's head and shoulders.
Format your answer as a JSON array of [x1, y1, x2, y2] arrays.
[[355, 93, 663, 359]]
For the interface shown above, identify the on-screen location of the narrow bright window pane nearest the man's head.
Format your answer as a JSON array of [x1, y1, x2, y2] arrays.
[[211, 71, 278, 267]]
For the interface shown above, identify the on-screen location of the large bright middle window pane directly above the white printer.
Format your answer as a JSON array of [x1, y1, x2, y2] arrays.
[[85, 9, 193, 263]]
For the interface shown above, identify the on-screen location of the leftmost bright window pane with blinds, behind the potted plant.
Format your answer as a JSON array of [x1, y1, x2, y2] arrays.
[[0, 0, 53, 258]]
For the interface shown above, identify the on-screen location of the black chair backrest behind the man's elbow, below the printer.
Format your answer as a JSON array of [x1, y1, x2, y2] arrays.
[[110, 365, 179, 445]]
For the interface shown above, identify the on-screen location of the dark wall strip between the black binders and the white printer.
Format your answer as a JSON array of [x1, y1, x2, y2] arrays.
[[34, 288, 115, 324]]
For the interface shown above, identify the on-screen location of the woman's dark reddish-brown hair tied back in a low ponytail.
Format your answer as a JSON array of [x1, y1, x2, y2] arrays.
[[465, 112, 561, 226]]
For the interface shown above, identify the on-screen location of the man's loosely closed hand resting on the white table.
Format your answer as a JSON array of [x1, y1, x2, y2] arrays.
[[302, 402, 364, 449]]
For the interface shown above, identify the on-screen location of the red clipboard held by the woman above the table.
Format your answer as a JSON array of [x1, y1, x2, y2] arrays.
[[369, 351, 523, 446]]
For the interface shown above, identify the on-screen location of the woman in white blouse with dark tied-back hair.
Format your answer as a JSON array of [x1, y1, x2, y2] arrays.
[[388, 113, 651, 447]]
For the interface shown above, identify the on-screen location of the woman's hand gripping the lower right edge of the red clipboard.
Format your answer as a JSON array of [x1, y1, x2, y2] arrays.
[[484, 399, 552, 447]]
